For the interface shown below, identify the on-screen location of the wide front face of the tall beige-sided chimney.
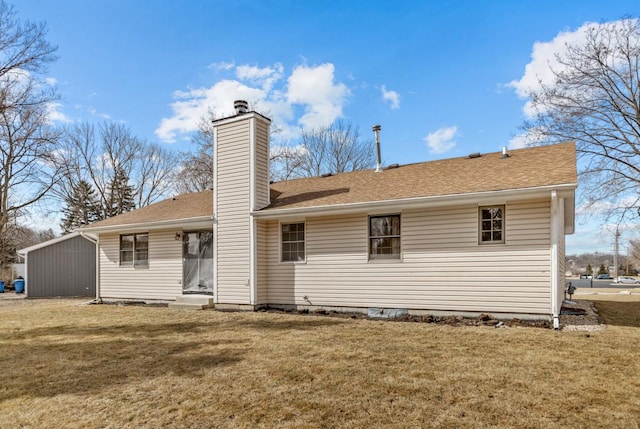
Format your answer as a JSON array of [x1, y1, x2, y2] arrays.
[[215, 121, 250, 304]]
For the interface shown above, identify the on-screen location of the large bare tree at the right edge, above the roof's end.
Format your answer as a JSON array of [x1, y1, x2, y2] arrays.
[[524, 19, 640, 223]]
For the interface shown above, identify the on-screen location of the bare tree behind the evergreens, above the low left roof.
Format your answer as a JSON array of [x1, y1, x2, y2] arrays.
[[55, 122, 176, 219]]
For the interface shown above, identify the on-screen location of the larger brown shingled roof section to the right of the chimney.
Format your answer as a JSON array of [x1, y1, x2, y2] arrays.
[[263, 143, 577, 211]]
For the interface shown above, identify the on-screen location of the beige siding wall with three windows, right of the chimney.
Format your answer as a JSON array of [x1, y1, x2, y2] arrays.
[[267, 200, 550, 314]]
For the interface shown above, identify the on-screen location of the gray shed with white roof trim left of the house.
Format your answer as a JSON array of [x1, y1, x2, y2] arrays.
[[18, 232, 96, 297]]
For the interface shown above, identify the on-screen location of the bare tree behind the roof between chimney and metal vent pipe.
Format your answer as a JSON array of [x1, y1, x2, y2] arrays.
[[272, 120, 375, 179]]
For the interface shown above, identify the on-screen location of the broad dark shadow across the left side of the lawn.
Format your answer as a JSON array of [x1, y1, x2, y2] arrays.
[[0, 324, 246, 402]]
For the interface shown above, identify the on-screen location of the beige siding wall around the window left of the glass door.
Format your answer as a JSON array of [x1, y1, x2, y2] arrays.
[[99, 230, 182, 300]]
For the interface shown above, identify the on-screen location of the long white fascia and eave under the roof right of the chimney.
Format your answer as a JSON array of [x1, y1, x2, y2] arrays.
[[251, 183, 577, 219]]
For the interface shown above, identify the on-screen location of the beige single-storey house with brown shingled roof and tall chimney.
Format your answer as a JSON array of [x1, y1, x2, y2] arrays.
[[84, 102, 577, 326]]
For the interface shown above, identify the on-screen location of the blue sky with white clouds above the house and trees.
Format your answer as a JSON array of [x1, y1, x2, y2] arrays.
[[13, 0, 640, 253]]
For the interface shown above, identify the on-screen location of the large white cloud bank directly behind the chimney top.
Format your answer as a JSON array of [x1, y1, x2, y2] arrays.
[[155, 63, 350, 142]]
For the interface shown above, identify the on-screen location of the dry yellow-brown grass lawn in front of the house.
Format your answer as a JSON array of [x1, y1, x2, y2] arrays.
[[0, 295, 640, 428]]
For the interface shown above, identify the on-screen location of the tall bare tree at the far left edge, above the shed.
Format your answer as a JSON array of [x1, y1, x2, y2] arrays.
[[0, 0, 58, 244]]
